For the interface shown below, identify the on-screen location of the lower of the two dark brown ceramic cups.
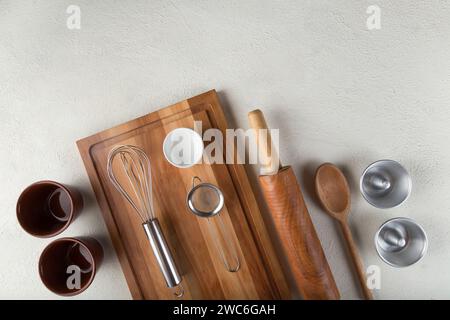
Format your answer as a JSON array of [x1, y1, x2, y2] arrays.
[[39, 237, 103, 296]]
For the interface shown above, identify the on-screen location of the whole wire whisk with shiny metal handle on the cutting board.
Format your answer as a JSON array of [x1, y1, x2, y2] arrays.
[[107, 145, 184, 297]]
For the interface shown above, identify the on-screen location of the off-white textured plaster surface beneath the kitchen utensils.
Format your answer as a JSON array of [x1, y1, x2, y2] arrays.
[[0, 0, 450, 299]]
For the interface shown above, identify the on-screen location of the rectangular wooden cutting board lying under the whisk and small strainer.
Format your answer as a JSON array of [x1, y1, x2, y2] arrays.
[[77, 90, 290, 299]]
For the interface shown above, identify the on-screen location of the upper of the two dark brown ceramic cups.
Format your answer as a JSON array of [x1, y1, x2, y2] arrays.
[[16, 181, 83, 238]]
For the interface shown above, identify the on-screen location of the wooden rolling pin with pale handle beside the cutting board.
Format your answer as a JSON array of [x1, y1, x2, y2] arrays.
[[248, 110, 340, 300]]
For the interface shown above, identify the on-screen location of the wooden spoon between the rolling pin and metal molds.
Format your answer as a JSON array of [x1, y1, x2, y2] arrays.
[[315, 163, 373, 300]]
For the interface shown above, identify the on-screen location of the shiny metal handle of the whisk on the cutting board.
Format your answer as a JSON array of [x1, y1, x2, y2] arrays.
[[142, 219, 181, 288]]
